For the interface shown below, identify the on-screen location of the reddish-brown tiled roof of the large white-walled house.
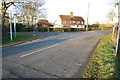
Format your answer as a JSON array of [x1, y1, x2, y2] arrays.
[[60, 15, 85, 22]]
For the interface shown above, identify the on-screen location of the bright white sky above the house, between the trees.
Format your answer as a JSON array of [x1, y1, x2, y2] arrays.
[[46, 0, 114, 24]]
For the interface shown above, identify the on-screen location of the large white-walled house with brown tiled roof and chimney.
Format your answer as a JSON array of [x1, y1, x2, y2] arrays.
[[54, 12, 85, 28]]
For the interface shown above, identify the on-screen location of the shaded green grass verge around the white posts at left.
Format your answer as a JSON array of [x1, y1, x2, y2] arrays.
[[0, 33, 40, 47]]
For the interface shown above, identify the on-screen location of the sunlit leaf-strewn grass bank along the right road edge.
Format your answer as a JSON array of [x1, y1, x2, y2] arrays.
[[83, 34, 120, 80]]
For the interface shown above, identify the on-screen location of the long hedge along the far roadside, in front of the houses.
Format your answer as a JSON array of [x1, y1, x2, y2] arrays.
[[12, 23, 112, 32]]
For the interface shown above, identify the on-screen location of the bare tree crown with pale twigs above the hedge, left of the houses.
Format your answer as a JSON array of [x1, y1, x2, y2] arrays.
[[14, 0, 46, 25]]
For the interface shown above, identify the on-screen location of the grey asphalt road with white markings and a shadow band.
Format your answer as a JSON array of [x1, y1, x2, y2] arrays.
[[2, 31, 110, 78]]
